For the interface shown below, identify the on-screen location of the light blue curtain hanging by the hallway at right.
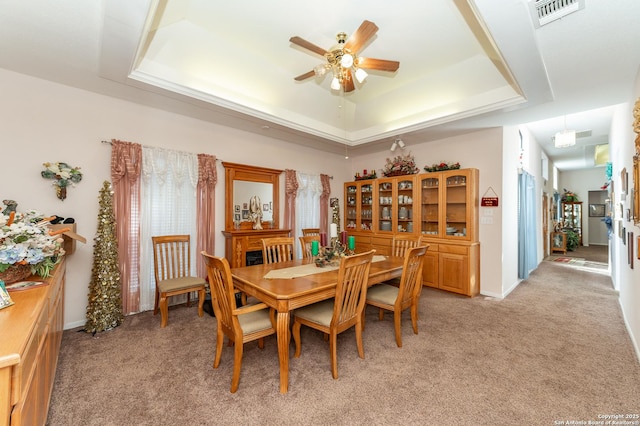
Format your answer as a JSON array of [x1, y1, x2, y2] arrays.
[[518, 170, 538, 279]]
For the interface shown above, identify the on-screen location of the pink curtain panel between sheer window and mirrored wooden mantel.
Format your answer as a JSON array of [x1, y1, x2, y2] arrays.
[[196, 154, 218, 277]]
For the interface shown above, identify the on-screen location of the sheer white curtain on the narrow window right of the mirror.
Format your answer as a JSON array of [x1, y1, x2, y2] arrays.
[[293, 172, 322, 258]]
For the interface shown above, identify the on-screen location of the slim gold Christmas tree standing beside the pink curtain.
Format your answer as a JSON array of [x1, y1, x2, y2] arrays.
[[84, 181, 124, 334]]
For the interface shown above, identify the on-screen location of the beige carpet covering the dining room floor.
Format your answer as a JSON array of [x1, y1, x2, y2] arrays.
[[49, 262, 640, 426]]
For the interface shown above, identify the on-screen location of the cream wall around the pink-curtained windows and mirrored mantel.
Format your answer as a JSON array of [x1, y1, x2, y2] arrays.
[[0, 69, 350, 328]]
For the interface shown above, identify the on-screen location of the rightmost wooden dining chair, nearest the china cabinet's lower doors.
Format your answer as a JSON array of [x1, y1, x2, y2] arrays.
[[362, 245, 429, 348]]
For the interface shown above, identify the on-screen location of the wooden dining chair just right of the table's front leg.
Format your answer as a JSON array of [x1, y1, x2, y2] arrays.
[[292, 250, 375, 379]]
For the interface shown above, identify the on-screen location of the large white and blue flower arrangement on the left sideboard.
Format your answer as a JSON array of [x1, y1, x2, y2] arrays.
[[0, 210, 65, 281]]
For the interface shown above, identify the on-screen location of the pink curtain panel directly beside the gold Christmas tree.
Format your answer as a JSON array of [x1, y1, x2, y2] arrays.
[[111, 139, 142, 315]]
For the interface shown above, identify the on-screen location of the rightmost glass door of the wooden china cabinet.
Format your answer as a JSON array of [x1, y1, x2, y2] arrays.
[[444, 171, 469, 238]]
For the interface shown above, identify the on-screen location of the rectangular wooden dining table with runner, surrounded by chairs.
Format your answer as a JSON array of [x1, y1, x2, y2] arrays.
[[231, 256, 404, 393]]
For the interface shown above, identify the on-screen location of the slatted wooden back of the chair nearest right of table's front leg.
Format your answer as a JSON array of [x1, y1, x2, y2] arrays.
[[331, 250, 375, 328]]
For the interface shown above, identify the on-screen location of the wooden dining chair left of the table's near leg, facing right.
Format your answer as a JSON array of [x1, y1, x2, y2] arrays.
[[201, 251, 276, 393]]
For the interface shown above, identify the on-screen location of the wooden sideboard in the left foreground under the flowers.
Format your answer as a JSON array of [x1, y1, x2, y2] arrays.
[[0, 260, 65, 426]]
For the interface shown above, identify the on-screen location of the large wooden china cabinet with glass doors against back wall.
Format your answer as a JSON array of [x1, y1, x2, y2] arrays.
[[344, 169, 480, 296]]
